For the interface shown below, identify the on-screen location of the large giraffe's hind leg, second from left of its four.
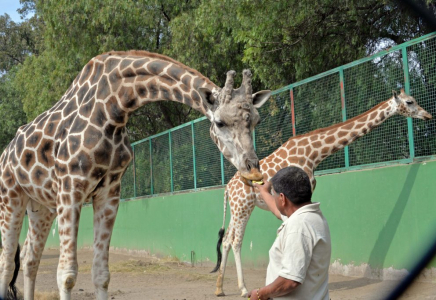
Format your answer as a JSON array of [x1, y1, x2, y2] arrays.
[[21, 201, 56, 300]]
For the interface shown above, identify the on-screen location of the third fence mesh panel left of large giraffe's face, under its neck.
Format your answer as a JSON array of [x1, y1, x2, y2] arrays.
[[151, 133, 171, 194]]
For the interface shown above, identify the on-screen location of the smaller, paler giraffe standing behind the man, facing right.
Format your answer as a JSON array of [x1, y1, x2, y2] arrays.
[[212, 90, 432, 297]]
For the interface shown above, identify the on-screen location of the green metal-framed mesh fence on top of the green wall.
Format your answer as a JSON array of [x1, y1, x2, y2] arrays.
[[121, 33, 436, 199]]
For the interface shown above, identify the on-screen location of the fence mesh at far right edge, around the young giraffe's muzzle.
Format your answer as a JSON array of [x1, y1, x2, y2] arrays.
[[408, 39, 436, 157]]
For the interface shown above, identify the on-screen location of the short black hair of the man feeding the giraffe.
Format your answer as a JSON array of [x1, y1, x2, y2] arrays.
[[271, 167, 312, 204]]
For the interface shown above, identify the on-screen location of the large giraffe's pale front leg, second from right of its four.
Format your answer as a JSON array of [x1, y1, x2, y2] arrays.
[[57, 192, 84, 300]]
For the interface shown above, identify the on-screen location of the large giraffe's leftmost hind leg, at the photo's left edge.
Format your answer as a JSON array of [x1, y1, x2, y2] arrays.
[[0, 195, 27, 299]]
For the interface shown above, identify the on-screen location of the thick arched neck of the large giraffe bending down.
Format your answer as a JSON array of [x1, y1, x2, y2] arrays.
[[76, 51, 219, 125]]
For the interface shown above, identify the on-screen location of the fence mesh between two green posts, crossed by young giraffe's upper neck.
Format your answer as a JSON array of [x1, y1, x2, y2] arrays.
[[344, 51, 410, 166]]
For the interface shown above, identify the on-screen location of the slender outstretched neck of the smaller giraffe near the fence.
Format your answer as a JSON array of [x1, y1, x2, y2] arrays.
[[298, 99, 397, 170]]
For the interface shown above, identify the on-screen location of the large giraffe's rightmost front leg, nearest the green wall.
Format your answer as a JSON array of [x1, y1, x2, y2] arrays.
[[92, 177, 120, 300]]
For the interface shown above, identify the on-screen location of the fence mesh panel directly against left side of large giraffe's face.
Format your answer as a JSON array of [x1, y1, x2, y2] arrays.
[[194, 119, 222, 188]]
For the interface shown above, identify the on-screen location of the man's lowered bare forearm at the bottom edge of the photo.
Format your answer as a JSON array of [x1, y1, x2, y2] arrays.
[[248, 276, 301, 300]]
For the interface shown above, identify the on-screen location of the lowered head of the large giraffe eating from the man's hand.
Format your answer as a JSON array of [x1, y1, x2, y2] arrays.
[[200, 70, 271, 180]]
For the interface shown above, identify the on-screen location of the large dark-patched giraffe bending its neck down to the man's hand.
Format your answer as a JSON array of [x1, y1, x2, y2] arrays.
[[0, 50, 270, 299]]
